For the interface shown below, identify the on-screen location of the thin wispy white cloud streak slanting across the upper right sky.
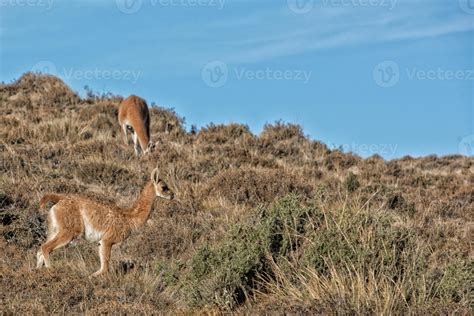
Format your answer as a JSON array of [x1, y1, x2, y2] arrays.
[[216, 2, 474, 63]]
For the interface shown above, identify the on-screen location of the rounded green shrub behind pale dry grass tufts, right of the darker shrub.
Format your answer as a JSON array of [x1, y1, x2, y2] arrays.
[[303, 211, 425, 282]]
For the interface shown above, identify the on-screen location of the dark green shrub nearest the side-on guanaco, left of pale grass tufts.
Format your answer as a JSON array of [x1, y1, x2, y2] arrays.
[[186, 195, 312, 309]]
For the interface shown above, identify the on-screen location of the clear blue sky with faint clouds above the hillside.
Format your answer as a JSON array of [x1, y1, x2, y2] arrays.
[[0, 0, 474, 159]]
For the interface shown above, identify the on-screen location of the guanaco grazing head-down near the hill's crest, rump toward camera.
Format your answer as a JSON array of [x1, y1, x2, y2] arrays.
[[118, 95, 154, 156]]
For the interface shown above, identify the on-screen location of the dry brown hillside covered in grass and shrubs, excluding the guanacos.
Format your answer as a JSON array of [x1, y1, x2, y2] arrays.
[[0, 73, 474, 314]]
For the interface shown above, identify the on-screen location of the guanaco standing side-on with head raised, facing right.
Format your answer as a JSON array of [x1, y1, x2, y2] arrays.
[[37, 169, 174, 276]]
